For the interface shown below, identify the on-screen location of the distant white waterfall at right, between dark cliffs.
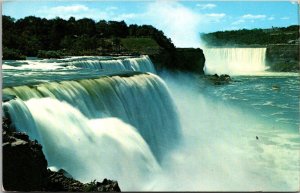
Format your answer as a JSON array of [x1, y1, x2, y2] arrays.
[[204, 48, 266, 75]]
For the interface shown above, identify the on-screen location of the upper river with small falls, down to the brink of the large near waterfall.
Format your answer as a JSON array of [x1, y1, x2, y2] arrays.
[[2, 56, 156, 87]]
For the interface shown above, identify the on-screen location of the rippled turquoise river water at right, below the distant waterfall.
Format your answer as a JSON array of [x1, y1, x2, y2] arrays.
[[205, 73, 300, 133]]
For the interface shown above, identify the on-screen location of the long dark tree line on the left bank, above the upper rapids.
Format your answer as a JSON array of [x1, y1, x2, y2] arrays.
[[2, 15, 175, 59]]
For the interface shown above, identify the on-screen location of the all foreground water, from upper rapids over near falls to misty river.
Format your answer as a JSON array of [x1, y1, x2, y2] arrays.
[[3, 57, 300, 191]]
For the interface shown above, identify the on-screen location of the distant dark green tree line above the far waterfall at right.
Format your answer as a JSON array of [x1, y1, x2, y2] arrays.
[[201, 25, 299, 46]]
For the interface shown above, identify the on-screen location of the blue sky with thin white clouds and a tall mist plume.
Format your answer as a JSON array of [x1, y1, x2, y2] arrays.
[[2, 0, 299, 47]]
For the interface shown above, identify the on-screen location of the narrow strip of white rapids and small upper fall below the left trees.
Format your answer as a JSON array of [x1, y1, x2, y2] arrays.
[[2, 55, 156, 74]]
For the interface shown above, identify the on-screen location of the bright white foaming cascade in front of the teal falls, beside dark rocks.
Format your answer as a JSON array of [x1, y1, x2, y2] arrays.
[[5, 98, 160, 189]]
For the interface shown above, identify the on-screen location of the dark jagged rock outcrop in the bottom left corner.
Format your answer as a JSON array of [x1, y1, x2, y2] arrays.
[[2, 117, 121, 192]]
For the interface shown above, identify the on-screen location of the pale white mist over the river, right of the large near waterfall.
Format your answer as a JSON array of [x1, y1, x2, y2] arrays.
[[145, 72, 297, 191]]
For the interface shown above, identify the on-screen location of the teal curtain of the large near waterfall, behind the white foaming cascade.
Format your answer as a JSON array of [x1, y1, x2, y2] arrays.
[[3, 74, 180, 160]]
